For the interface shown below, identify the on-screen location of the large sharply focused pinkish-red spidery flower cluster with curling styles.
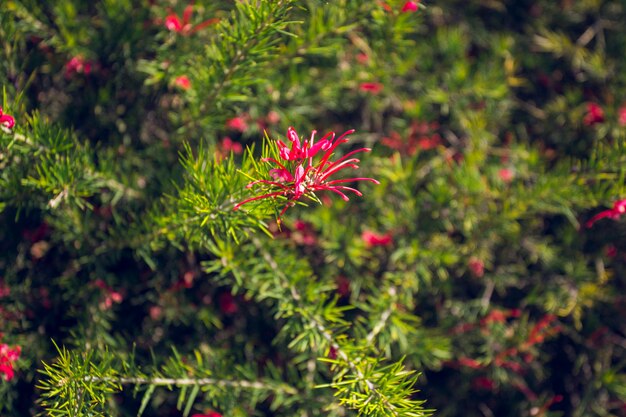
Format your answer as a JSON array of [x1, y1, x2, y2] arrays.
[[234, 127, 379, 223]]
